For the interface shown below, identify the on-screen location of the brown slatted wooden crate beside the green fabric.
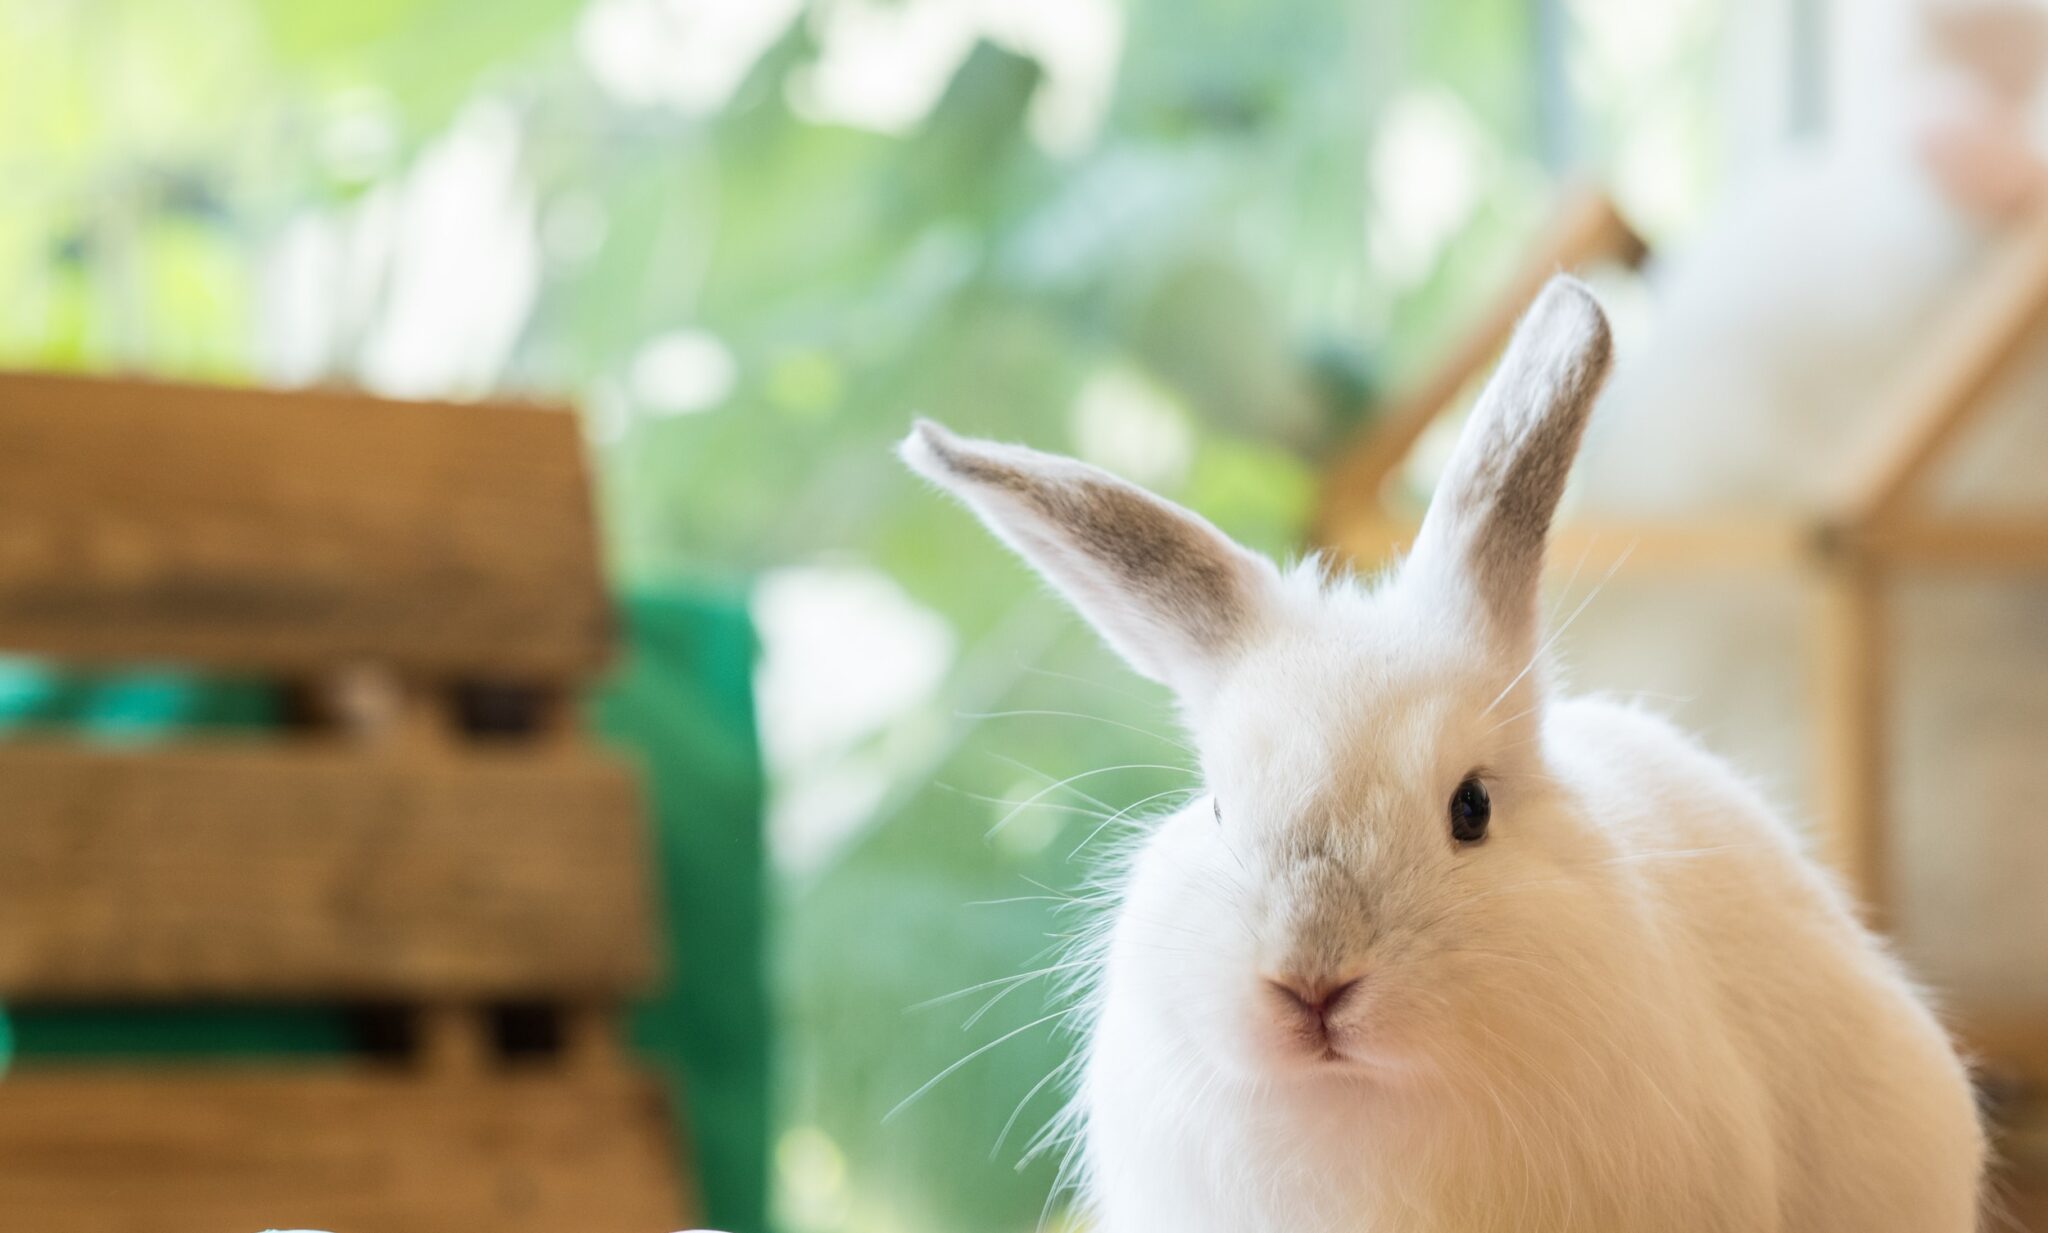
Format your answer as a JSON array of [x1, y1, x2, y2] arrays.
[[0, 375, 692, 1233]]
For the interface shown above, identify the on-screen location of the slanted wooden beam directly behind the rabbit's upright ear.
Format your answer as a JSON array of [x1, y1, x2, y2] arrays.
[[1315, 186, 1649, 545]]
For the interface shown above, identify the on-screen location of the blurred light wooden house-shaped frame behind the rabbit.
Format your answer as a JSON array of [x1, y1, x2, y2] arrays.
[[1317, 188, 2048, 1083]]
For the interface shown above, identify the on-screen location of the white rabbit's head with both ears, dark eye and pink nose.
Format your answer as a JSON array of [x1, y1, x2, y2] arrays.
[[903, 279, 1610, 1077]]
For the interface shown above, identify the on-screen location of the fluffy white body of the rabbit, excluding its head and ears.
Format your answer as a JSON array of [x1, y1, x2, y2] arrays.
[[1081, 698, 1982, 1233]]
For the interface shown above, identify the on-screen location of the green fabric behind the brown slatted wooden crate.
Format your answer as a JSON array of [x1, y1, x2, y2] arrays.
[[0, 592, 768, 1233]]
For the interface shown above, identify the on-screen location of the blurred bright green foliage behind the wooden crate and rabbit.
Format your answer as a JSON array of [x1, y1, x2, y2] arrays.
[[0, 0, 1736, 1233]]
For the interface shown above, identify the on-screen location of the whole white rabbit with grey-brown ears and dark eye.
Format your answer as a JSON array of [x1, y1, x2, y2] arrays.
[[903, 281, 1985, 1233]]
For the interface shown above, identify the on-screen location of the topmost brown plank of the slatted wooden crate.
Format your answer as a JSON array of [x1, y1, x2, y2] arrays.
[[0, 375, 610, 678]]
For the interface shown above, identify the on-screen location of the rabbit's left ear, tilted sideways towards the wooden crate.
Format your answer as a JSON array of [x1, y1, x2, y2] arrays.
[[901, 420, 1278, 700]]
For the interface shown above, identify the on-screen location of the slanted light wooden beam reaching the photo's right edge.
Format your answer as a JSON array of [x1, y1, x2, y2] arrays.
[[1839, 205, 2048, 528]]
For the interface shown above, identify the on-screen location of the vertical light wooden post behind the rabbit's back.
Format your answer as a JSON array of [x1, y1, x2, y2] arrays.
[[1810, 551, 1890, 930]]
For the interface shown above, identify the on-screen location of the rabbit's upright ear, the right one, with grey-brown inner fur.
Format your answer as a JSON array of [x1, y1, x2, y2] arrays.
[[1409, 277, 1614, 653]]
